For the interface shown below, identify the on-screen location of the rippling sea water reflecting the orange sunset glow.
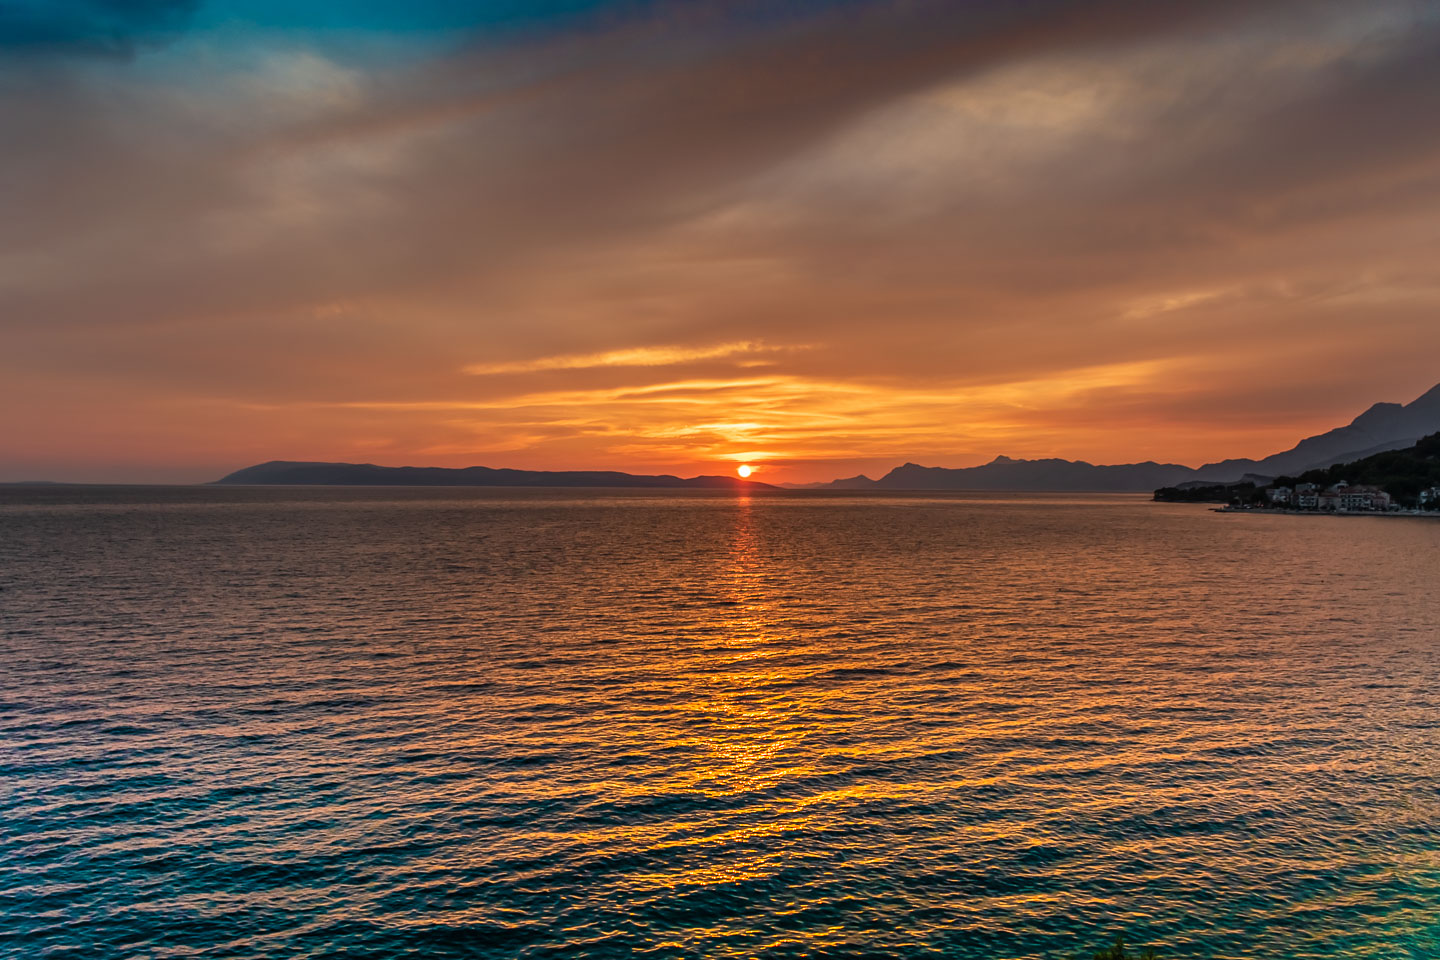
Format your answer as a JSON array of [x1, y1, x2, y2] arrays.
[[0, 488, 1440, 960]]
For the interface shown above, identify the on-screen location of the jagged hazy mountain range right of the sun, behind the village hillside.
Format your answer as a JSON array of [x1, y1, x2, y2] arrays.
[[806, 384, 1440, 494]]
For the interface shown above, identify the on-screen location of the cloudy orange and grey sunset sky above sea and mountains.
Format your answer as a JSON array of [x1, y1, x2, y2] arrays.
[[0, 0, 1440, 482]]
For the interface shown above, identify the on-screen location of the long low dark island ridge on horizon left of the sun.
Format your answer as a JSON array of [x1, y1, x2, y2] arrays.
[[215, 461, 778, 489]]
